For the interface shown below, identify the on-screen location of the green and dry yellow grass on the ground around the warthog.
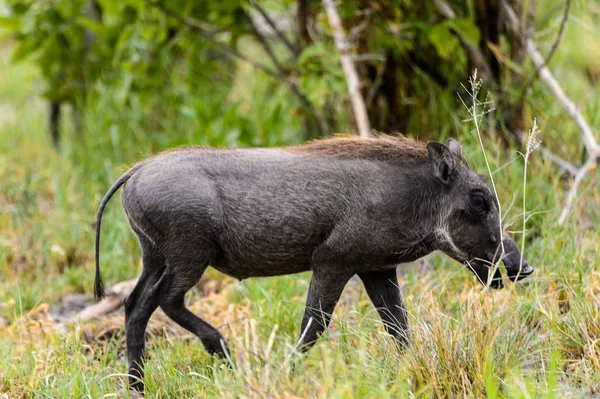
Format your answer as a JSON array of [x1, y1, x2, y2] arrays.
[[0, 1, 600, 398]]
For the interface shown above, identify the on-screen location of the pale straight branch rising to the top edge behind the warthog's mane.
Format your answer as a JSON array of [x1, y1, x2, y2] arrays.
[[322, 0, 372, 137]]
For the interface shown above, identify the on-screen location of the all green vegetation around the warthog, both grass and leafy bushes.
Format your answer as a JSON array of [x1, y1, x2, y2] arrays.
[[0, 0, 600, 398]]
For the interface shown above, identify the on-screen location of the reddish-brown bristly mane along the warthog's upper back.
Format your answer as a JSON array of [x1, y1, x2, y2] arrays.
[[282, 133, 429, 160]]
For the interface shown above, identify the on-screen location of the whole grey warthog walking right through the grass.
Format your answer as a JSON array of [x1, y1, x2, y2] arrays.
[[95, 136, 533, 390]]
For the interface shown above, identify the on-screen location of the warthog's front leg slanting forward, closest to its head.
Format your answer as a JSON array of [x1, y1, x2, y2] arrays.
[[358, 268, 409, 347]]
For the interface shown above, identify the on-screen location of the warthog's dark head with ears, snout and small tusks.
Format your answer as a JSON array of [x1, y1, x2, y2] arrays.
[[427, 139, 533, 288]]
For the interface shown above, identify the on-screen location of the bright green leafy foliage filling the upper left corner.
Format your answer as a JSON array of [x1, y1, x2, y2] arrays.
[[4, 0, 244, 119]]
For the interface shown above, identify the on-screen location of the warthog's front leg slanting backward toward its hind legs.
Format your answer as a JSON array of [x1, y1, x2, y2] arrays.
[[298, 269, 352, 351]]
